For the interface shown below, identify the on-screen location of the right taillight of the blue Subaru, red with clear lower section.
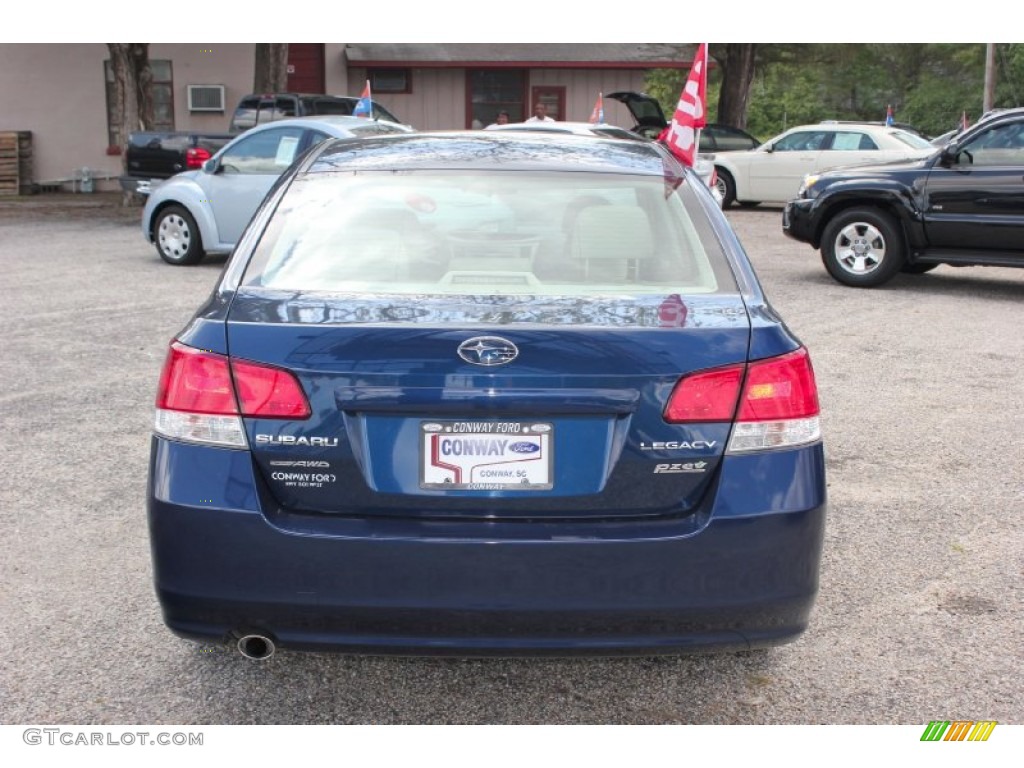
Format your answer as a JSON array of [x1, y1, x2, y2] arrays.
[[665, 348, 821, 454]]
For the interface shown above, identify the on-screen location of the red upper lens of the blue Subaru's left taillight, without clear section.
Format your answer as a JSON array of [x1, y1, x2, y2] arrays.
[[157, 342, 311, 419]]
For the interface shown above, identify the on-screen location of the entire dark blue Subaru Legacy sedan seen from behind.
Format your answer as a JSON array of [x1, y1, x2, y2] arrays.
[[148, 132, 825, 658]]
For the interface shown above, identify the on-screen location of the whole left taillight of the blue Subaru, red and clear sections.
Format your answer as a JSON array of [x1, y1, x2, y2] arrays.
[[156, 342, 310, 447]]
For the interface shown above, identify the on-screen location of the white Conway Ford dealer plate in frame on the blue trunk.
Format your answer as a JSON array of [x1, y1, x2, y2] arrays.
[[420, 421, 554, 490]]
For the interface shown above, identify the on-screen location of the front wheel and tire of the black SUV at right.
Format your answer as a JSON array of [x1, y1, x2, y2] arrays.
[[821, 208, 904, 288]]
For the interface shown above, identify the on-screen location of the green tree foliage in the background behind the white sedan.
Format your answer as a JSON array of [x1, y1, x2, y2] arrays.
[[645, 43, 1024, 139]]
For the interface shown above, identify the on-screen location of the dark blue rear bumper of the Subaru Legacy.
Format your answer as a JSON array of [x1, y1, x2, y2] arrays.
[[150, 439, 825, 655]]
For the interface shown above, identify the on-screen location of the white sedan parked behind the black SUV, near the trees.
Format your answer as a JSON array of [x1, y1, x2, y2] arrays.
[[715, 123, 935, 207]]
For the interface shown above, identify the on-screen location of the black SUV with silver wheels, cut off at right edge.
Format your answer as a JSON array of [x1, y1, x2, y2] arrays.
[[782, 109, 1024, 288]]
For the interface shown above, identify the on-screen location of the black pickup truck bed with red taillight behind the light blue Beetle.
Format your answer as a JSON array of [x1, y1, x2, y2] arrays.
[[119, 131, 234, 195]]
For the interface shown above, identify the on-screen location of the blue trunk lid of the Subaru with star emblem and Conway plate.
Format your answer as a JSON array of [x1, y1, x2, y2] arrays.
[[228, 292, 750, 518]]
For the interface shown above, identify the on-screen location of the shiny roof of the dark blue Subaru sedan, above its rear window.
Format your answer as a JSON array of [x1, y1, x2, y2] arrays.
[[304, 131, 684, 178]]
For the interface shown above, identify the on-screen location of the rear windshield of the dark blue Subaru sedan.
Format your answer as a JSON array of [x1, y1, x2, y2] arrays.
[[244, 171, 735, 296]]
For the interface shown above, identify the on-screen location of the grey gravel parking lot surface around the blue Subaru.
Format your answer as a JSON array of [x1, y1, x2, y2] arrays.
[[0, 195, 1024, 725]]
